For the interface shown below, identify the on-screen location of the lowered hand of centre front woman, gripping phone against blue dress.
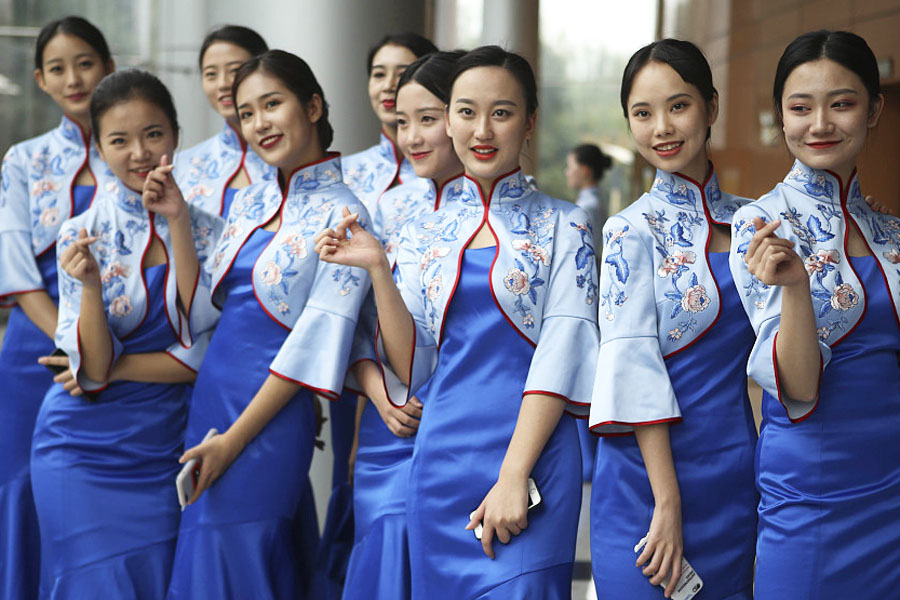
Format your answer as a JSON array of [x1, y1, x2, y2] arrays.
[[466, 474, 528, 559]]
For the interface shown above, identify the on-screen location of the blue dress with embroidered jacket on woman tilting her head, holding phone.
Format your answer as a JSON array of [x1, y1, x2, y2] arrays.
[[168, 154, 369, 599]]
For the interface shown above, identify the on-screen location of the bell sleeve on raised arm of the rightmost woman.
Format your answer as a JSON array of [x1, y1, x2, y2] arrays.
[[728, 203, 831, 423]]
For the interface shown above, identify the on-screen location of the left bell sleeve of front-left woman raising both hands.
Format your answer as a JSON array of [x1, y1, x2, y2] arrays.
[[55, 219, 124, 392]]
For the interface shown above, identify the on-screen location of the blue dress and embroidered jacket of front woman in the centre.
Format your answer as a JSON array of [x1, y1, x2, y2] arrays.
[[380, 170, 599, 599]]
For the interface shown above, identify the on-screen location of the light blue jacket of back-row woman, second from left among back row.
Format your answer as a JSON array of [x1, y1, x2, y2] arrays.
[[174, 122, 277, 218]]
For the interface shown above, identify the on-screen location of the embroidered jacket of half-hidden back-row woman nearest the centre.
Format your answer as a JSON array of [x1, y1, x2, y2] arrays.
[[343, 132, 418, 215]]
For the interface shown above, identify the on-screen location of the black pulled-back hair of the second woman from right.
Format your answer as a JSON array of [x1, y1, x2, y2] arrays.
[[619, 38, 719, 140]]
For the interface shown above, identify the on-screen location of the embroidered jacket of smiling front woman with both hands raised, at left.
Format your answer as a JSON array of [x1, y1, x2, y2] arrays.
[[56, 176, 223, 391]]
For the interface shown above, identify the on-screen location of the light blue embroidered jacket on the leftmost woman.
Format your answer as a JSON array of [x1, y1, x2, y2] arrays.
[[0, 116, 107, 303]]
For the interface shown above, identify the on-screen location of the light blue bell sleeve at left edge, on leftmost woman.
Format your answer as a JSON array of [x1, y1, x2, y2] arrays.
[[0, 146, 45, 307]]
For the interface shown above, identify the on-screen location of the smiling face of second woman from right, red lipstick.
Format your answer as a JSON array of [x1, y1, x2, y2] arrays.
[[628, 61, 718, 182]]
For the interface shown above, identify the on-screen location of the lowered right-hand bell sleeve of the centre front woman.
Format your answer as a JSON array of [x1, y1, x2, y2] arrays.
[[522, 206, 600, 419]]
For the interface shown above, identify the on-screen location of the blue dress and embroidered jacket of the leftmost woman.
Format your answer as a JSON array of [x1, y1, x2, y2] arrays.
[[0, 116, 106, 600]]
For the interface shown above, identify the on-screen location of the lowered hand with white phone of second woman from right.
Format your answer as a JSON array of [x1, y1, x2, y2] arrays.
[[634, 504, 684, 598]]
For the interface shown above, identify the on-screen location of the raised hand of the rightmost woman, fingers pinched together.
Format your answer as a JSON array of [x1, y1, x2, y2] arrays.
[[744, 217, 809, 287]]
